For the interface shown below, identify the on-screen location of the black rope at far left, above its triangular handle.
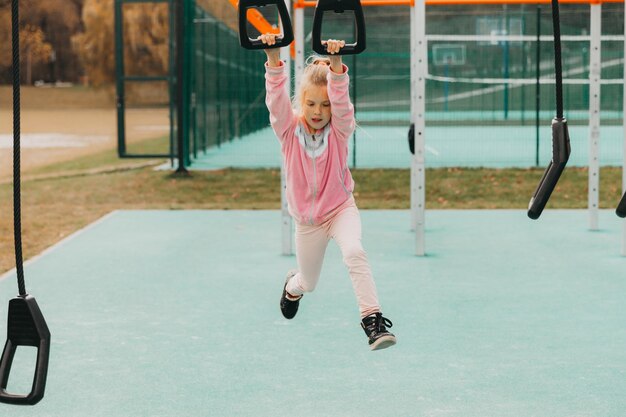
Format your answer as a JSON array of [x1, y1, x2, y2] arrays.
[[11, 0, 26, 296]]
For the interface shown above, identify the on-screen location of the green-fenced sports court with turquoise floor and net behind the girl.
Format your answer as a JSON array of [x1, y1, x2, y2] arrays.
[[147, 3, 624, 167]]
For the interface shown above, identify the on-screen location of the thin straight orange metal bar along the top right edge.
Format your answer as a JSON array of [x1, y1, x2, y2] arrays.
[[293, 0, 624, 9]]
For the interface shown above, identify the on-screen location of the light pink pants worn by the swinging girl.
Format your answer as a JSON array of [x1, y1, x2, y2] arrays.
[[287, 198, 380, 318]]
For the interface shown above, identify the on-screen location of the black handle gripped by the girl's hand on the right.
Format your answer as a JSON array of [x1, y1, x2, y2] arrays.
[[313, 0, 366, 55]]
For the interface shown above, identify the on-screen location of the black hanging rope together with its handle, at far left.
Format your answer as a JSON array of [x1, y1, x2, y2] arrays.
[[0, 0, 50, 405]]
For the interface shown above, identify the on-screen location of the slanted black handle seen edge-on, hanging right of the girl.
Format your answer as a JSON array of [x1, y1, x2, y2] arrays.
[[528, 118, 571, 220]]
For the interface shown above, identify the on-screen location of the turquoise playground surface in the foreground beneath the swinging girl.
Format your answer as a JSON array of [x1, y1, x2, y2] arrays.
[[0, 210, 626, 417]]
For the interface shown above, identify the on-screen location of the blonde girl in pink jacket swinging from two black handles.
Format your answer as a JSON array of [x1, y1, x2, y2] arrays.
[[259, 34, 396, 350]]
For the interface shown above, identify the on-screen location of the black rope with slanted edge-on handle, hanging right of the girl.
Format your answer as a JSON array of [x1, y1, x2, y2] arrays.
[[527, 0, 571, 220]]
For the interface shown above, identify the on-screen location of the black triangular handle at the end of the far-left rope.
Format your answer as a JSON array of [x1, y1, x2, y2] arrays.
[[0, 294, 50, 405]]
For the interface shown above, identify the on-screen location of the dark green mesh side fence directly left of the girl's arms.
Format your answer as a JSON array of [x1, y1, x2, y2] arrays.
[[187, 6, 268, 156]]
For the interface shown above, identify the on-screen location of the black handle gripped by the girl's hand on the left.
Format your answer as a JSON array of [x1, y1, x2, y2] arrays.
[[238, 0, 293, 49]]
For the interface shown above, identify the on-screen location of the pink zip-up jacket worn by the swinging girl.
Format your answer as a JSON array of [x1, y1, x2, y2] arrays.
[[265, 63, 355, 225]]
